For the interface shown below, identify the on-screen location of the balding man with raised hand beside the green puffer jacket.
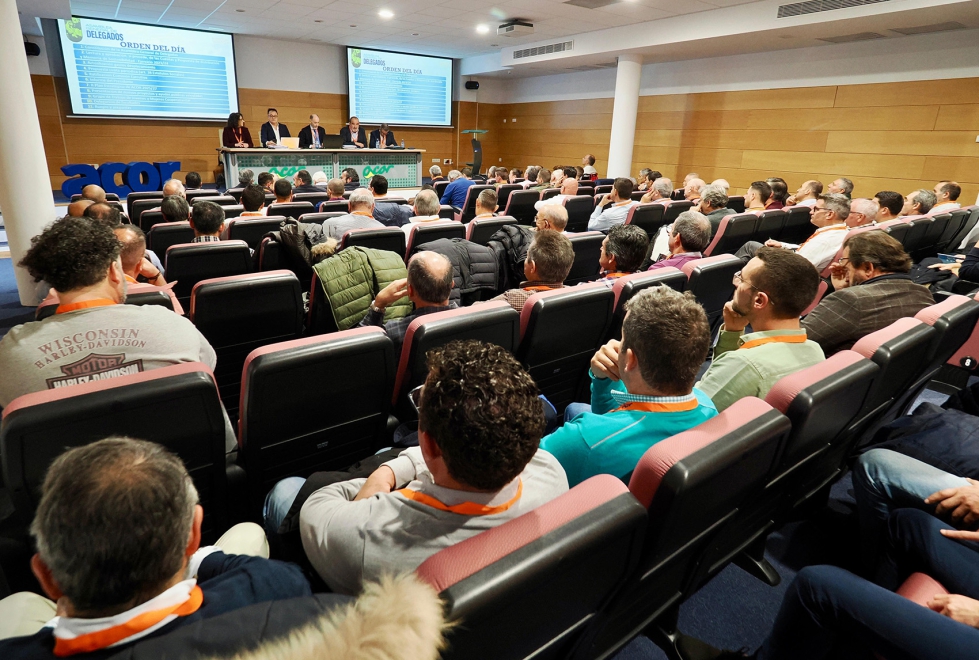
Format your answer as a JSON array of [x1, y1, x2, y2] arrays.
[[358, 250, 458, 360]]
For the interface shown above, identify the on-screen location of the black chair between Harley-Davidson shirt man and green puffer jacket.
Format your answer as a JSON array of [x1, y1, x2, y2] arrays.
[[190, 270, 304, 422]]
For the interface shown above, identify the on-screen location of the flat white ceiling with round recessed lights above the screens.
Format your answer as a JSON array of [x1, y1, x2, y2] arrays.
[[59, 0, 754, 58]]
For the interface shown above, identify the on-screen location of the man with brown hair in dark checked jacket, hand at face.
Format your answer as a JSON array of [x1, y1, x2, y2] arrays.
[[802, 231, 935, 355]]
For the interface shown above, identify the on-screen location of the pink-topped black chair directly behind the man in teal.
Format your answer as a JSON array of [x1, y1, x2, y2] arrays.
[[577, 397, 789, 658]]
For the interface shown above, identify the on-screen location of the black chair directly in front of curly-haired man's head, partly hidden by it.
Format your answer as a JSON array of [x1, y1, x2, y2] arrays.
[[391, 300, 520, 420]]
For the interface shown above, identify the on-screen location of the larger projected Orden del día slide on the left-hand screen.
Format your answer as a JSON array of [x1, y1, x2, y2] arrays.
[[58, 18, 238, 121]]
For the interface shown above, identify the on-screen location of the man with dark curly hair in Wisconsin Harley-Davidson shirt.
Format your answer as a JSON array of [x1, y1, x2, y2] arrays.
[[0, 219, 220, 407]]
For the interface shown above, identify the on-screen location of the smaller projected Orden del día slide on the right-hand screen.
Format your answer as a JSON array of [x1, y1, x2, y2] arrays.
[[347, 48, 452, 126]]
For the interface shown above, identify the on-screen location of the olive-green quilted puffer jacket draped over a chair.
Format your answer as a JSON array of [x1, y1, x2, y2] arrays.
[[313, 246, 413, 330]]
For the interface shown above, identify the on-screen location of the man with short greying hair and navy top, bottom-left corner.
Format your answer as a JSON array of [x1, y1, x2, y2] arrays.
[[0, 438, 311, 660]]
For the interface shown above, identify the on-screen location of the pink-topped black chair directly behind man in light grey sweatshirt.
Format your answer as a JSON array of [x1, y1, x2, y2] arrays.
[[417, 475, 646, 659]]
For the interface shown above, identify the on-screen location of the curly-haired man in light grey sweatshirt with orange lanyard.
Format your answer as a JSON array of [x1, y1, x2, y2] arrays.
[[266, 340, 568, 594]]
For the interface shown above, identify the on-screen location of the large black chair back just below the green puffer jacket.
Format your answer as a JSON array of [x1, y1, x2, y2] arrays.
[[238, 328, 395, 511]]
